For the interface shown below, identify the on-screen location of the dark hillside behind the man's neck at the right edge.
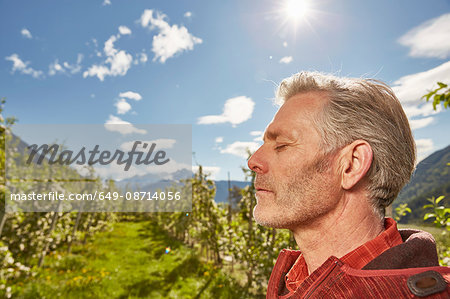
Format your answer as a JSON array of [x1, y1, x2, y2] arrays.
[[394, 146, 450, 222]]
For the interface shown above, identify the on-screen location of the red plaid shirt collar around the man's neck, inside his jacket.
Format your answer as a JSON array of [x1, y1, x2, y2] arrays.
[[284, 218, 403, 292]]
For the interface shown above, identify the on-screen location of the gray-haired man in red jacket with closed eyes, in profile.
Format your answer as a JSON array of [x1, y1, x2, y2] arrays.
[[248, 72, 450, 298]]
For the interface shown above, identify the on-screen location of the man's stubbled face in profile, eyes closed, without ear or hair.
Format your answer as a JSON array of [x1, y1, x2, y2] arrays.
[[248, 92, 339, 229]]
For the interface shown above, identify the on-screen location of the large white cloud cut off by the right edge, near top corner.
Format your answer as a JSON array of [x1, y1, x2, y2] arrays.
[[399, 13, 450, 59]]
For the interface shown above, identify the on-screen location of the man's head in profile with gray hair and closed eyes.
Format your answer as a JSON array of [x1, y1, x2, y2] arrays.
[[249, 72, 415, 227]]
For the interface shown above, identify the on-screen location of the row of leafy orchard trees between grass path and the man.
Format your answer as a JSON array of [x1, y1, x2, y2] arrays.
[[154, 166, 295, 297]]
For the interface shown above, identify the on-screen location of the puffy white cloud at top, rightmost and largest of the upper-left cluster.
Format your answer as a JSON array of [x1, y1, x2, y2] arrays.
[[139, 9, 203, 63]]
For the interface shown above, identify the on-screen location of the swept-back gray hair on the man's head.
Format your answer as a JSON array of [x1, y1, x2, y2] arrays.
[[276, 72, 416, 217]]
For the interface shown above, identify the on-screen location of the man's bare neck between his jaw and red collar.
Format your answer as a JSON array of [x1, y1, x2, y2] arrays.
[[292, 200, 384, 274]]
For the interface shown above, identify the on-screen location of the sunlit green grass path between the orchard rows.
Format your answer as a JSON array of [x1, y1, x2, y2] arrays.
[[13, 222, 253, 298]]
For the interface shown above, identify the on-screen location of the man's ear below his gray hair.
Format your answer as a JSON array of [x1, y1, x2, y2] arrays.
[[340, 140, 373, 190]]
